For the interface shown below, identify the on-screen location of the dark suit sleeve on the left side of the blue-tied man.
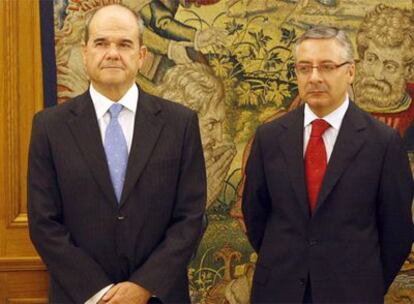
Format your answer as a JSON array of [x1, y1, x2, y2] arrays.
[[27, 113, 112, 303]]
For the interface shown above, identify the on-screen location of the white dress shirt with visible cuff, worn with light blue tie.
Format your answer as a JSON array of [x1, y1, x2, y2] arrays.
[[85, 84, 138, 304]]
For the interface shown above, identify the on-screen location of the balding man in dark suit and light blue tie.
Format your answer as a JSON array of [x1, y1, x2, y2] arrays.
[[28, 5, 206, 303]]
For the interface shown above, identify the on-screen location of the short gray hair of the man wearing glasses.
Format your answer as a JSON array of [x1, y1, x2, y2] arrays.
[[295, 26, 354, 62]]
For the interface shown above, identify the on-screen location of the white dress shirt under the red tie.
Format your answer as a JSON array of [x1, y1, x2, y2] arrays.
[[303, 95, 349, 162]]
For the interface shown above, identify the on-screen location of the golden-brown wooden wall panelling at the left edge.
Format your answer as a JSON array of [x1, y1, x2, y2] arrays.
[[0, 0, 48, 303]]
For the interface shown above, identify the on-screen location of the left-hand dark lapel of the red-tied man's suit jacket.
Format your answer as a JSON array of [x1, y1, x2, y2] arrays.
[[280, 106, 309, 218]]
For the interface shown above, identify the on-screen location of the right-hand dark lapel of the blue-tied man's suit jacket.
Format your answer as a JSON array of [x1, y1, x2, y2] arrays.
[[120, 90, 164, 206]]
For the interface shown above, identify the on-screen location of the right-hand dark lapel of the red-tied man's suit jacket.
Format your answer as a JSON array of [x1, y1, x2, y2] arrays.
[[315, 102, 366, 212]]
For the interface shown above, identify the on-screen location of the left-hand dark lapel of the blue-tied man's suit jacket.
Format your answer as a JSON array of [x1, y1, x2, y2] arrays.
[[68, 91, 117, 206]]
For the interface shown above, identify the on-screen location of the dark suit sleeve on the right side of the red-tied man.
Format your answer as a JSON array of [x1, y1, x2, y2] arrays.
[[377, 132, 414, 291]]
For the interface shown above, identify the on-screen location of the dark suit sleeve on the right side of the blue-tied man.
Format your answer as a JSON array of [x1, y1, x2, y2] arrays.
[[130, 112, 207, 300]]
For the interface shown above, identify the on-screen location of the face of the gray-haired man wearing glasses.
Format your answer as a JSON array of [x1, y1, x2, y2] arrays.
[[296, 39, 355, 117]]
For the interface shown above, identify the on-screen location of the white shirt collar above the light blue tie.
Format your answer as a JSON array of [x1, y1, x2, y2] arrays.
[[89, 83, 139, 120]]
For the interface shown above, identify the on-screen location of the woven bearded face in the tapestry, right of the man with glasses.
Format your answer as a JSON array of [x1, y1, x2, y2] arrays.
[[354, 41, 407, 108]]
